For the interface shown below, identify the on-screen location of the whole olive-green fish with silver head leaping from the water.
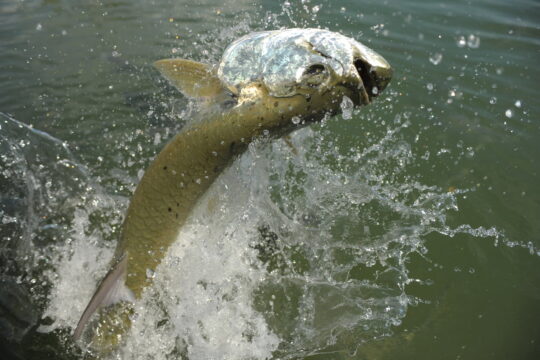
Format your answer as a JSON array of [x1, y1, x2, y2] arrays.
[[73, 29, 392, 349]]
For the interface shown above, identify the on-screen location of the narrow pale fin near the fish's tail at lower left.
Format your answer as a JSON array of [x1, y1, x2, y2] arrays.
[[73, 255, 135, 340]]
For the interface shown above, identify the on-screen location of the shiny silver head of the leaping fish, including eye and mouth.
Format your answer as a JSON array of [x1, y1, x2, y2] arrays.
[[217, 29, 392, 111]]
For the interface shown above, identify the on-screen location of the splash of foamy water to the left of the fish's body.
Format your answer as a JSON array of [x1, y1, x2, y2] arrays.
[[0, 113, 127, 348]]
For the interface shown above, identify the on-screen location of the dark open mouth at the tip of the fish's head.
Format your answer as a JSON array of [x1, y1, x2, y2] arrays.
[[345, 59, 393, 106]]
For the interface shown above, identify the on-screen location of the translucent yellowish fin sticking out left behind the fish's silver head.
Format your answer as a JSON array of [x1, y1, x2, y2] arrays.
[[154, 59, 225, 98]]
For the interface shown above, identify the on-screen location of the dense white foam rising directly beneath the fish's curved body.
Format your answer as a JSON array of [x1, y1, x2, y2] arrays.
[[122, 147, 279, 359]]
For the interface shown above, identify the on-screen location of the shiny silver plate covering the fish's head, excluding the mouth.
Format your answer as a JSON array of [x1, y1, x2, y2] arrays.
[[218, 29, 360, 97]]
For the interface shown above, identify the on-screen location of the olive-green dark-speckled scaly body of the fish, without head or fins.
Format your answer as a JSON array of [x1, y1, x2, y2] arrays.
[[117, 86, 362, 298]]
